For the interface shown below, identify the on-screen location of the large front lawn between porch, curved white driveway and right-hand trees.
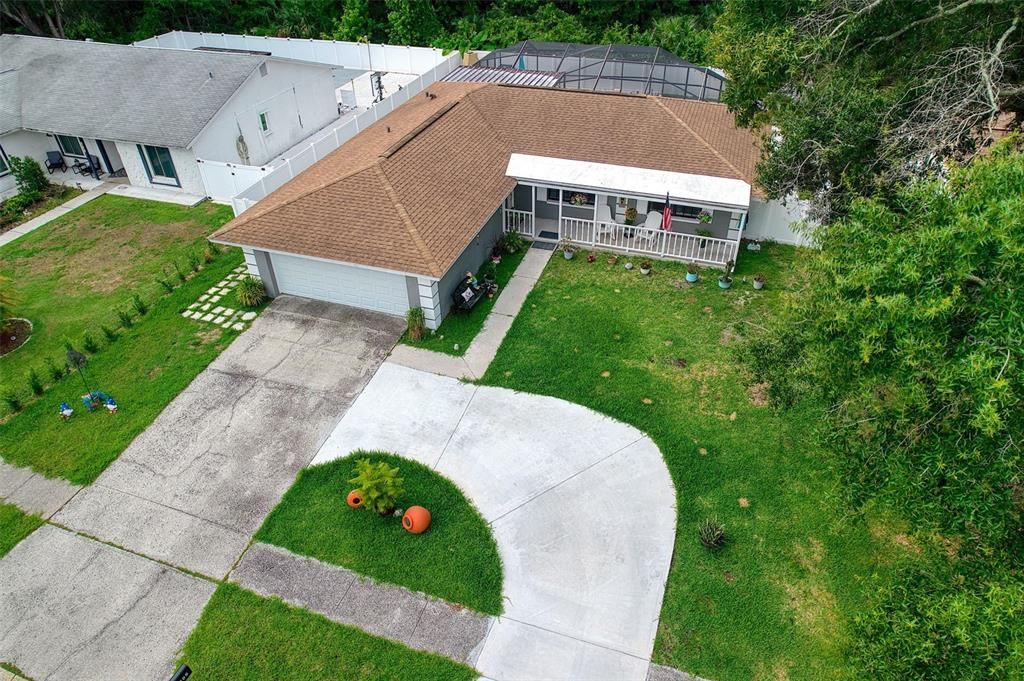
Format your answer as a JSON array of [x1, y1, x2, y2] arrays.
[[482, 245, 921, 681]]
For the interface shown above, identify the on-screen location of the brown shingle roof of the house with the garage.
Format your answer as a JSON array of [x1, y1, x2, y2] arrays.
[[212, 82, 758, 278]]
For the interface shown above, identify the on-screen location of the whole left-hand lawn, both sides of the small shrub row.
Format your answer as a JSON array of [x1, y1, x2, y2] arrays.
[[0, 197, 256, 484]]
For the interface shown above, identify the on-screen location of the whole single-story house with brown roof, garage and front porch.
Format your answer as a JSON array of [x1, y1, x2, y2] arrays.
[[211, 82, 790, 328]]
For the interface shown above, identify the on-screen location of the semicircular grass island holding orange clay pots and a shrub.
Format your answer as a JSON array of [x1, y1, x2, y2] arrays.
[[256, 452, 502, 614]]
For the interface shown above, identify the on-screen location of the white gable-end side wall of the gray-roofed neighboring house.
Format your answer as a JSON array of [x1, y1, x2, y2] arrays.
[[193, 60, 338, 167]]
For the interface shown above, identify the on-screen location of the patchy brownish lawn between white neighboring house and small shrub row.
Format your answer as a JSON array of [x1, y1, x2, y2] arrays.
[[0, 196, 231, 399]]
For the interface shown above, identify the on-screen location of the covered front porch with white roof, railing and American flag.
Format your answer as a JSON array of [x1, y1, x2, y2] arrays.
[[503, 154, 750, 267]]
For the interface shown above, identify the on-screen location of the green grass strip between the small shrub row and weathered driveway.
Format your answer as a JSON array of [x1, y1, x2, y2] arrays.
[[0, 250, 251, 484]]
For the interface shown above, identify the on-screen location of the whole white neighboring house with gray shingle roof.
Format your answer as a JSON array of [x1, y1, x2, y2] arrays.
[[0, 35, 338, 197]]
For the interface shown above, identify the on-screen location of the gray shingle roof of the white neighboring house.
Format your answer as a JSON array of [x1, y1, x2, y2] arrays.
[[0, 35, 266, 147]]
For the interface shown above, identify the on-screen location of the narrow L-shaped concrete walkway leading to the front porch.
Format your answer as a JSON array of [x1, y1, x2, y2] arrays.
[[388, 248, 551, 381]]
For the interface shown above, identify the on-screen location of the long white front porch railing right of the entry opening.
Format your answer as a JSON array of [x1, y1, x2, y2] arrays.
[[560, 217, 739, 267]]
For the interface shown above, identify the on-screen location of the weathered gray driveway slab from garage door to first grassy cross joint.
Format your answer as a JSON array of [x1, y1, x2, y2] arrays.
[[54, 296, 404, 579]]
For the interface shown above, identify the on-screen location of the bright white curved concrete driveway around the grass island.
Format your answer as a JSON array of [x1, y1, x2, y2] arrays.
[[313, 361, 676, 681]]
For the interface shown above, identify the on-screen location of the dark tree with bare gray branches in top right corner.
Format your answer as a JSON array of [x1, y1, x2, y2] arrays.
[[712, 0, 1024, 219]]
